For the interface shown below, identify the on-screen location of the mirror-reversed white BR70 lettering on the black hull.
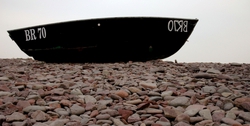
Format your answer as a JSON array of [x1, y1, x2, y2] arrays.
[[168, 20, 188, 32]]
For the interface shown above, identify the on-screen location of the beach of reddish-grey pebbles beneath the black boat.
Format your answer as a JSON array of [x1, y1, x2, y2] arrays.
[[0, 59, 250, 126]]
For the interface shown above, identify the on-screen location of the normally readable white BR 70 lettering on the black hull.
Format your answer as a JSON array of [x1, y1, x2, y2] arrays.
[[24, 27, 46, 41]]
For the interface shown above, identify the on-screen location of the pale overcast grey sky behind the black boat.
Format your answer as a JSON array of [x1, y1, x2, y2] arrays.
[[0, 0, 250, 63]]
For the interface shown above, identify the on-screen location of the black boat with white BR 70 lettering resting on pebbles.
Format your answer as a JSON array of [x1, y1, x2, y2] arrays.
[[7, 17, 198, 63]]
